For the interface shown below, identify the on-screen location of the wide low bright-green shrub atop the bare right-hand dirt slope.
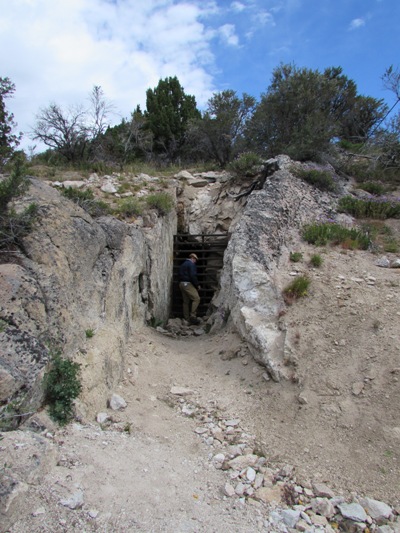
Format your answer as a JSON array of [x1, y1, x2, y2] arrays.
[[302, 222, 371, 250]]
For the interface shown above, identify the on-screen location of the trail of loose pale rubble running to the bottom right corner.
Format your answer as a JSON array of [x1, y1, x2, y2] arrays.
[[170, 387, 400, 533]]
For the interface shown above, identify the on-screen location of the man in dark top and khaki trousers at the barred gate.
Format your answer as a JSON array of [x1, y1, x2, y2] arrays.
[[179, 254, 201, 324]]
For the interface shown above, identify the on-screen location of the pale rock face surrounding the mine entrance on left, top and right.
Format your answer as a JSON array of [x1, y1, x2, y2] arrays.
[[0, 156, 356, 416]]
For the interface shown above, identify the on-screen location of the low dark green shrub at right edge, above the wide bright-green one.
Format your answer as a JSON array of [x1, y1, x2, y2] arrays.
[[338, 196, 400, 220]]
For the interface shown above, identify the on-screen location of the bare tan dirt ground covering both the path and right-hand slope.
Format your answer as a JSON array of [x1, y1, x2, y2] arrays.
[[3, 228, 400, 533]]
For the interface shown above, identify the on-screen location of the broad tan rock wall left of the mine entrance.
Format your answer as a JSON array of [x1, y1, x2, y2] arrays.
[[0, 179, 176, 416]]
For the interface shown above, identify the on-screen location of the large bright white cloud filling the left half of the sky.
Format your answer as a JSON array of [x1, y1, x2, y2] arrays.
[[0, 0, 219, 147]]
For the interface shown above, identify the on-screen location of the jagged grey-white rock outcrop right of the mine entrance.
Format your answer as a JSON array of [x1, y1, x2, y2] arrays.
[[213, 156, 332, 381]]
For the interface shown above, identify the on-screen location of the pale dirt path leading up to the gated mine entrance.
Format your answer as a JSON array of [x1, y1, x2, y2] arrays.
[[5, 329, 263, 533]]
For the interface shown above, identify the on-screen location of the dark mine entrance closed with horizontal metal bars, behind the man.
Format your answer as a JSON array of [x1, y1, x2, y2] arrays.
[[171, 233, 229, 317]]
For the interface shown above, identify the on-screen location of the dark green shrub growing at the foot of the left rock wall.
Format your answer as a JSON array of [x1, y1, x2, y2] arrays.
[[43, 354, 82, 426]]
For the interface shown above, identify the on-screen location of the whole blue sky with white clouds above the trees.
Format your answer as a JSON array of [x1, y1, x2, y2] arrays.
[[0, 0, 400, 148]]
